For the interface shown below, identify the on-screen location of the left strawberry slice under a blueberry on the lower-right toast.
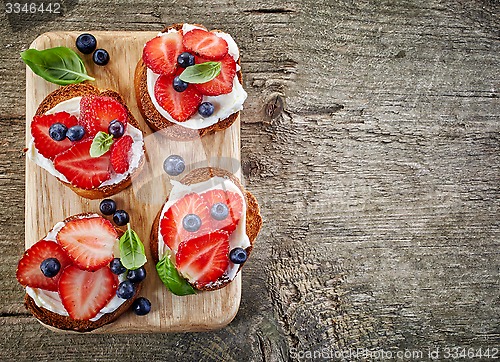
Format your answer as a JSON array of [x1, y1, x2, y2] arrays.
[[160, 193, 210, 252]]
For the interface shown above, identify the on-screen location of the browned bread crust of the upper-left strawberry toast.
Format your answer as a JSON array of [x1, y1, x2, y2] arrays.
[[35, 83, 145, 199]]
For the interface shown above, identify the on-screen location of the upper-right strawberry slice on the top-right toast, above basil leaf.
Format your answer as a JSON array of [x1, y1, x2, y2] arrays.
[[182, 29, 228, 60]]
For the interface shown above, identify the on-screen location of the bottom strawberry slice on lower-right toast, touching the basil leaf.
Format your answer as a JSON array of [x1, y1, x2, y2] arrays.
[[175, 231, 229, 287]]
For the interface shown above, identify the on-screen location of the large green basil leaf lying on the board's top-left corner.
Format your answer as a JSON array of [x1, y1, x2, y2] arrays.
[[21, 47, 95, 85]]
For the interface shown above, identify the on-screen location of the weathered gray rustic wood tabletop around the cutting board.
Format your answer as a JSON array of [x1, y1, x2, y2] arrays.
[[0, 0, 500, 361]]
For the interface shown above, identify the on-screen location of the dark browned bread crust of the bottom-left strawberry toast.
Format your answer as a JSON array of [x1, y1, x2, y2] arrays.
[[24, 213, 142, 332]]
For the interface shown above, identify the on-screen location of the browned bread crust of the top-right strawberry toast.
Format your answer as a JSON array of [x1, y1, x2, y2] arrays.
[[134, 24, 243, 141]]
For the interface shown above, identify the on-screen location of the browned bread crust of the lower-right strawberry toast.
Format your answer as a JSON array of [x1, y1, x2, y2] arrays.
[[149, 167, 262, 290]]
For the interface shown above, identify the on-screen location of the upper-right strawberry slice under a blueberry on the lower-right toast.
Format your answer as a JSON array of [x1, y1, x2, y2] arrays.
[[201, 190, 243, 233]]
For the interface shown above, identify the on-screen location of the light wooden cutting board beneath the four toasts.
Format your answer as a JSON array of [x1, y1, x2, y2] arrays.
[[25, 31, 241, 333]]
